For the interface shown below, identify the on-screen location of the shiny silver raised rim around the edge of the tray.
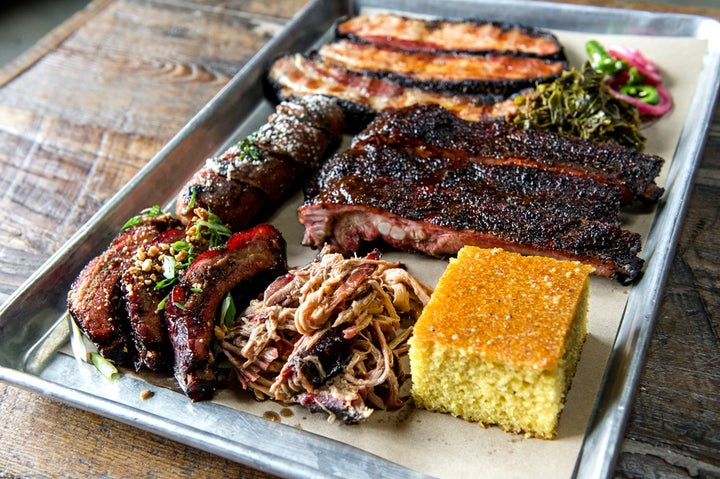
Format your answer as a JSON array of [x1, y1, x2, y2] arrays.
[[0, 0, 720, 477]]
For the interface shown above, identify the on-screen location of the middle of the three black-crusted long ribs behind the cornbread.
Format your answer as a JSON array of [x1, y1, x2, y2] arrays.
[[306, 144, 620, 225]]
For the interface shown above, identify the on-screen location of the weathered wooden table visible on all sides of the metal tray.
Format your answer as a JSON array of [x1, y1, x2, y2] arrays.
[[0, 0, 720, 478]]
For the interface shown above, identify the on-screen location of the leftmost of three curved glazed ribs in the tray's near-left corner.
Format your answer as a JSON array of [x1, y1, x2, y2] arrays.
[[68, 214, 176, 365]]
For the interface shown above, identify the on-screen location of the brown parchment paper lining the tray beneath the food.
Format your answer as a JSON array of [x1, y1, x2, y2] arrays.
[[65, 25, 707, 479]]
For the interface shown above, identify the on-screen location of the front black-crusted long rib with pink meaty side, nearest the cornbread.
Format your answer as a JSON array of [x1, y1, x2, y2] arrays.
[[299, 177, 643, 283]]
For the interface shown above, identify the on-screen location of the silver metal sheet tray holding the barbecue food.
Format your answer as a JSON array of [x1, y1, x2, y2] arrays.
[[0, 0, 720, 478]]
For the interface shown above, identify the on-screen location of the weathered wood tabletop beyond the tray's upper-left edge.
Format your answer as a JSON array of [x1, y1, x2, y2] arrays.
[[0, 0, 304, 300]]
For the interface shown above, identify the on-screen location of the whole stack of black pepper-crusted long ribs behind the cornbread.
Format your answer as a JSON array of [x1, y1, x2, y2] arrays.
[[299, 106, 659, 283]]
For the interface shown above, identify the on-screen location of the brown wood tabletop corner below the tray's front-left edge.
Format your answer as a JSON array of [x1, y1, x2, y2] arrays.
[[0, 384, 273, 479]]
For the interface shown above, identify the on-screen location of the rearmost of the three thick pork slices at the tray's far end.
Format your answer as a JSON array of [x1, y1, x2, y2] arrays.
[[336, 14, 563, 58]]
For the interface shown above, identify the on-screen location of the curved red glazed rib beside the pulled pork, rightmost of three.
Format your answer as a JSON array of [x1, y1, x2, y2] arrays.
[[166, 224, 287, 401]]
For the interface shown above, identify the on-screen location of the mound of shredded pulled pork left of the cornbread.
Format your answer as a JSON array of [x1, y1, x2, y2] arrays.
[[222, 249, 431, 424]]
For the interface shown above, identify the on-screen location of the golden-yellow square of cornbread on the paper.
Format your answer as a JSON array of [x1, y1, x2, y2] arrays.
[[409, 246, 593, 439]]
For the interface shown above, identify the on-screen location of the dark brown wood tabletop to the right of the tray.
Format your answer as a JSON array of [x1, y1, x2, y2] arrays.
[[618, 103, 720, 477]]
